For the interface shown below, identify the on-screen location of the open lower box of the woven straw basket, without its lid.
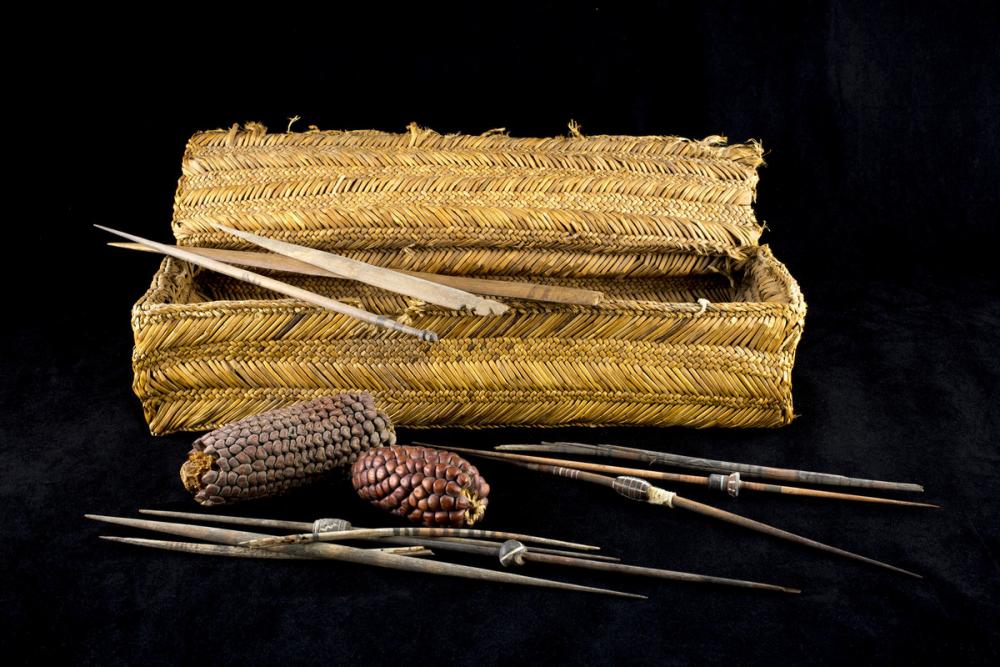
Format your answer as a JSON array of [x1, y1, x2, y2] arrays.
[[132, 246, 806, 434]]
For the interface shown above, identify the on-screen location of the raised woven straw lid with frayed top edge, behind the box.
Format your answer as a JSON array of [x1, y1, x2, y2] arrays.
[[173, 123, 763, 277]]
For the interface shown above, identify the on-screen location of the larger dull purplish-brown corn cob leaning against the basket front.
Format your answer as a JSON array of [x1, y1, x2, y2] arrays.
[[181, 392, 396, 505]]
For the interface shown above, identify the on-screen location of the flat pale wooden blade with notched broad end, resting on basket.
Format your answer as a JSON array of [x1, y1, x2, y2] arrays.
[[208, 222, 508, 315]]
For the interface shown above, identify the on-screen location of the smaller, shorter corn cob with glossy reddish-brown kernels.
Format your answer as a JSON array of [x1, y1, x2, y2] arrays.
[[351, 445, 490, 527]]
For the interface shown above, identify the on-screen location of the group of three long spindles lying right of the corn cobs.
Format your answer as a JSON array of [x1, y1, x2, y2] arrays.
[[428, 442, 937, 578]]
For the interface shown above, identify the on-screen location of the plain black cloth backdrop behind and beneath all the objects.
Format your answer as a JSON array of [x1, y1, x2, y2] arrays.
[[0, 2, 1000, 664]]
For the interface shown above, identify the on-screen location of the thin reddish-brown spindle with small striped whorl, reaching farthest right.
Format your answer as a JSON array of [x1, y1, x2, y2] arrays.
[[438, 442, 940, 508]]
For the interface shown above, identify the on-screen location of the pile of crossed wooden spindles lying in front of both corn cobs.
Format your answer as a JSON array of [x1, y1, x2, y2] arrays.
[[86, 510, 799, 599]]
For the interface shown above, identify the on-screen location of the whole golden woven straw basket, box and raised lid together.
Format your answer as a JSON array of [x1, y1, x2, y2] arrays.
[[133, 125, 805, 433]]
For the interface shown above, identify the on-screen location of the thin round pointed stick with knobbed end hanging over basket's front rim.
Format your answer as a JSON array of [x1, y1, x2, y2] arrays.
[[94, 225, 438, 342]]
